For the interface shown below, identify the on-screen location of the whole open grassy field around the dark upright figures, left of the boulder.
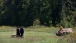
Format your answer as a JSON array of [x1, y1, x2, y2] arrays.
[[0, 26, 60, 43]]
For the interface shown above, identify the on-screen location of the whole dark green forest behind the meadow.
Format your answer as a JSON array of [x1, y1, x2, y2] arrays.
[[0, 0, 76, 27]]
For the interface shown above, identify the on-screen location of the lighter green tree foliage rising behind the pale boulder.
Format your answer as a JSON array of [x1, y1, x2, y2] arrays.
[[60, 0, 74, 27]]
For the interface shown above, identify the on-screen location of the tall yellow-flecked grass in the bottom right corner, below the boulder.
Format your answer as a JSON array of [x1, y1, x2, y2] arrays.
[[57, 32, 76, 43]]
